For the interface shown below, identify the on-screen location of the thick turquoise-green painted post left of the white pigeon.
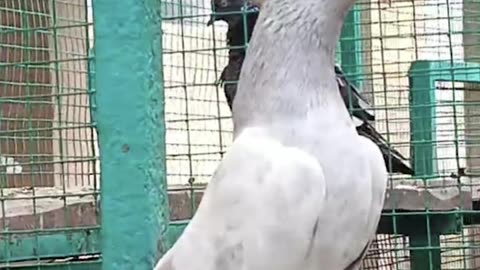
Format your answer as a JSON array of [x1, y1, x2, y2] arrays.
[[94, 0, 168, 270]]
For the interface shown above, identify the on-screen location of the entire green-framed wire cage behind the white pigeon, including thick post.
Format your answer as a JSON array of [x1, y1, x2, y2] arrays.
[[0, 0, 480, 270]]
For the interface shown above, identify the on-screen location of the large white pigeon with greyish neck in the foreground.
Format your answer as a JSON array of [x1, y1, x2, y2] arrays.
[[154, 0, 387, 270]]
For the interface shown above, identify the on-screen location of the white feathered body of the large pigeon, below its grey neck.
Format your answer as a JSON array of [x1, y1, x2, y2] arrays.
[[155, 123, 386, 270]]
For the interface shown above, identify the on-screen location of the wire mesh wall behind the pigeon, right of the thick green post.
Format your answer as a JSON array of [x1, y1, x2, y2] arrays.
[[162, 0, 480, 270]]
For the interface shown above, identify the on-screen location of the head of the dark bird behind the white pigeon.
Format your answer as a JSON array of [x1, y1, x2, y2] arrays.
[[207, 0, 263, 26]]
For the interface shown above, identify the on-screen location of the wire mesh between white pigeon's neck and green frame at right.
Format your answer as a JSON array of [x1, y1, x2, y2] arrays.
[[362, 0, 463, 170]]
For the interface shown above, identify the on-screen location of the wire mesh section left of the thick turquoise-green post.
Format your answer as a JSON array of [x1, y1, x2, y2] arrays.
[[0, 0, 99, 266]]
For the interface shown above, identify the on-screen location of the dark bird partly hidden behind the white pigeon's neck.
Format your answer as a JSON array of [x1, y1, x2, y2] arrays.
[[207, 0, 414, 175]]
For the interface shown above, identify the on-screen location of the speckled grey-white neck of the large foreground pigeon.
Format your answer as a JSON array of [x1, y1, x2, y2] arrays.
[[233, 0, 354, 134]]
